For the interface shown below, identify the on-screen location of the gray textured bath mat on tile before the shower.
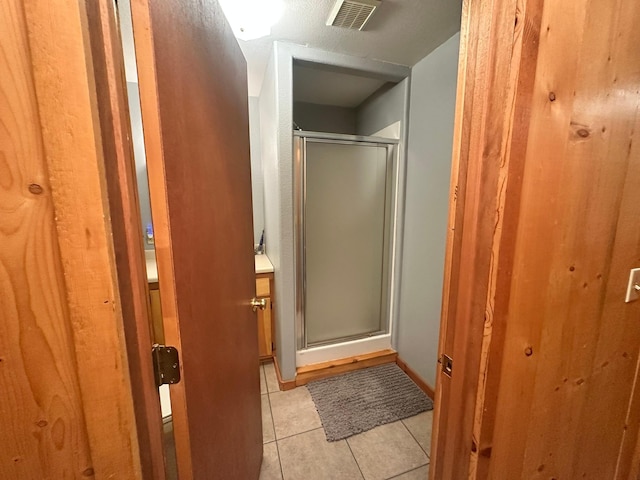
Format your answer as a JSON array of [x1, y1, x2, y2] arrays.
[[307, 363, 433, 442]]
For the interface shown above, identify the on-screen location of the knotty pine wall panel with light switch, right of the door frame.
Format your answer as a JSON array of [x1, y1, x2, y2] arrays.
[[491, 1, 640, 478]]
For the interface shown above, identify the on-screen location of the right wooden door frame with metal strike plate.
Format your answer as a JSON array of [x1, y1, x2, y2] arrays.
[[430, 0, 535, 479]]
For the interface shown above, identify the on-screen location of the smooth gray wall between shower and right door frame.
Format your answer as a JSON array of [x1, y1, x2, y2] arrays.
[[397, 34, 460, 387]]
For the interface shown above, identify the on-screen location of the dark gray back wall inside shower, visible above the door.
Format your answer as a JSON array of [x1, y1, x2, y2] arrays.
[[293, 102, 357, 135]]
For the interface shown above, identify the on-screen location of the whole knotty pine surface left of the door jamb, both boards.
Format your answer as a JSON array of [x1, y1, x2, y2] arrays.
[[0, 0, 141, 479]]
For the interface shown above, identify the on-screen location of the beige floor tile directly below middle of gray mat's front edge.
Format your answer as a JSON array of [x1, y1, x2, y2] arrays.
[[347, 421, 429, 480]]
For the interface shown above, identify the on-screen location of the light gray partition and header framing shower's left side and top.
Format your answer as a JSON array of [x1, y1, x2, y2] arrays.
[[260, 42, 410, 380]]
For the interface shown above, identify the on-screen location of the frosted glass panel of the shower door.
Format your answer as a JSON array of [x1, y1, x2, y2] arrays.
[[303, 139, 392, 347]]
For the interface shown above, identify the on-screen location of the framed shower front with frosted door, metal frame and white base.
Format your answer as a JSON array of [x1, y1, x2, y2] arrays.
[[294, 131, 397, 365]]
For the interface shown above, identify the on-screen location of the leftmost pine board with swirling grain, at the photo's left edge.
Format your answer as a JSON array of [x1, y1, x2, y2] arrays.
[[0, 1, 92, 479]]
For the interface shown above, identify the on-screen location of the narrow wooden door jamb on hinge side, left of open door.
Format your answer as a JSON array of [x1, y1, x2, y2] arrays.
[[83, 0, 166, 480]]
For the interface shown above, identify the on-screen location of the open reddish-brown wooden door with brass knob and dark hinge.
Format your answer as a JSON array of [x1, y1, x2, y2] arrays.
[[131, 0, 262, 480]]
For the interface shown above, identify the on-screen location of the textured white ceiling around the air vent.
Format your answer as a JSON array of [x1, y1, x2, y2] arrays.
[[239, 0, 462, 96]]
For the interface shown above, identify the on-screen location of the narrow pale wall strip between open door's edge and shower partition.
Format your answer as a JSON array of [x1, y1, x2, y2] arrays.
[[249, 97, 264, 244]]
